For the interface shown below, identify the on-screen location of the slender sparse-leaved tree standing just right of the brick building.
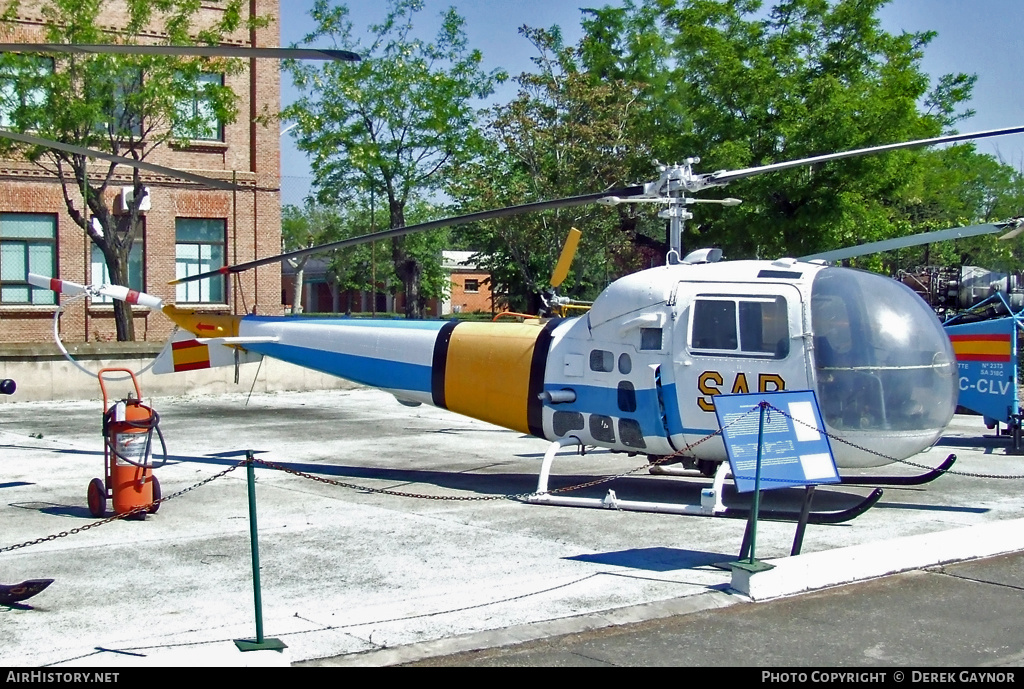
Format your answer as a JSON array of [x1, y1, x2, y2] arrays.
[[284, 0, 503, 318]]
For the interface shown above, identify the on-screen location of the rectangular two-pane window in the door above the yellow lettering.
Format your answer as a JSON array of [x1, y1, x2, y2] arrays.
[[690, 297, 790, 359]]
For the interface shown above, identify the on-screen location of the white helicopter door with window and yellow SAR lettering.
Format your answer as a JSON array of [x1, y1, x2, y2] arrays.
[[673, 283, 811, 461]]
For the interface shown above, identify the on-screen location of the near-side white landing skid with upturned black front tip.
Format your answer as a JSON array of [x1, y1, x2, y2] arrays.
[[526, 436, 882, 524]]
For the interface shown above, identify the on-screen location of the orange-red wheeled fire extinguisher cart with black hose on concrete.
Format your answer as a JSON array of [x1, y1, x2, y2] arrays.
[[88, 369, 167, 519]]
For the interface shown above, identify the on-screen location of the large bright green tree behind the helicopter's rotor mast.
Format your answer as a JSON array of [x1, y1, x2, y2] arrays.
[[565, 0, 987, 258]]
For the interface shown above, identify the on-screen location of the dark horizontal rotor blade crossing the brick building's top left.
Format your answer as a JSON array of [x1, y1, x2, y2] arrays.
[[0, 43, 359, 62]]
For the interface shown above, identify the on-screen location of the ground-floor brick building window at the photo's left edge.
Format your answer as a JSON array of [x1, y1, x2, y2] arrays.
[[0, 213, 57, 304]]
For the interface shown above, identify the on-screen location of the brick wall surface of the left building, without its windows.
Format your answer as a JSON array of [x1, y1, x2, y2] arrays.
[[0, 0, 282, 343]]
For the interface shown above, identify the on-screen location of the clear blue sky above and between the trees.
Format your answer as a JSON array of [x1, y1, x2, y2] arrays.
[[281, 0, 1024, 203]]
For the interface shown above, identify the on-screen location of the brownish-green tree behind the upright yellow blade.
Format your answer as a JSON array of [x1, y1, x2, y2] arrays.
[[452, 27, 650, 313]]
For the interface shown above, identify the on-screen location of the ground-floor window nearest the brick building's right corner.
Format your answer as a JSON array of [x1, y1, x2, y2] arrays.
[[174, 218, 227, 304]]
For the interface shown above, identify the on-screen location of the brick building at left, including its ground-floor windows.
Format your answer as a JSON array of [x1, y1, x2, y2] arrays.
[[0, 0, 282, 343]]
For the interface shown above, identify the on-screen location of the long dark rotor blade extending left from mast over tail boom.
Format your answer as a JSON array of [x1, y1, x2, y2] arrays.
[[170, 184, 644, 285]]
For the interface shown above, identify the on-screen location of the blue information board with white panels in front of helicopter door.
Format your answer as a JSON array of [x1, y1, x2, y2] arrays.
[[712, 390, 840, 492]]
